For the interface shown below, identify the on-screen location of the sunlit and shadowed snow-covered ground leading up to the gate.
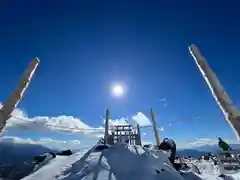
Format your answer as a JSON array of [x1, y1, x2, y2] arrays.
[[20, 144, 240, 180]]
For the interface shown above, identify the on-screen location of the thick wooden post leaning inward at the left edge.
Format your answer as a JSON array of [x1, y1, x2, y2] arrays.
[[0, 58, 40, 134]]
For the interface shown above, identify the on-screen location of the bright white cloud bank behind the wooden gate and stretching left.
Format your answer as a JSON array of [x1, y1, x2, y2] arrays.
[[0, 106, 151, 137]]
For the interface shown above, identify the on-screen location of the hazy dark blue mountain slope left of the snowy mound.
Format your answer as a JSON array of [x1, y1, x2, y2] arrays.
[[0, 142, 53, 179]]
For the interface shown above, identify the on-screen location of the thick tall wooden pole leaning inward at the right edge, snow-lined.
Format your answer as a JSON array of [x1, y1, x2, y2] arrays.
[[189, 44, 240, 139]]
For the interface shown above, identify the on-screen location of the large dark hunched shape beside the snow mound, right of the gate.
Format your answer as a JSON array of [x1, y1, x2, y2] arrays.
[[159, 138, 177, 164]]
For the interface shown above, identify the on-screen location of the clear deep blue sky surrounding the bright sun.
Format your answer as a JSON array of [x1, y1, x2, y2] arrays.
[[0, 0, 240, 148]]
